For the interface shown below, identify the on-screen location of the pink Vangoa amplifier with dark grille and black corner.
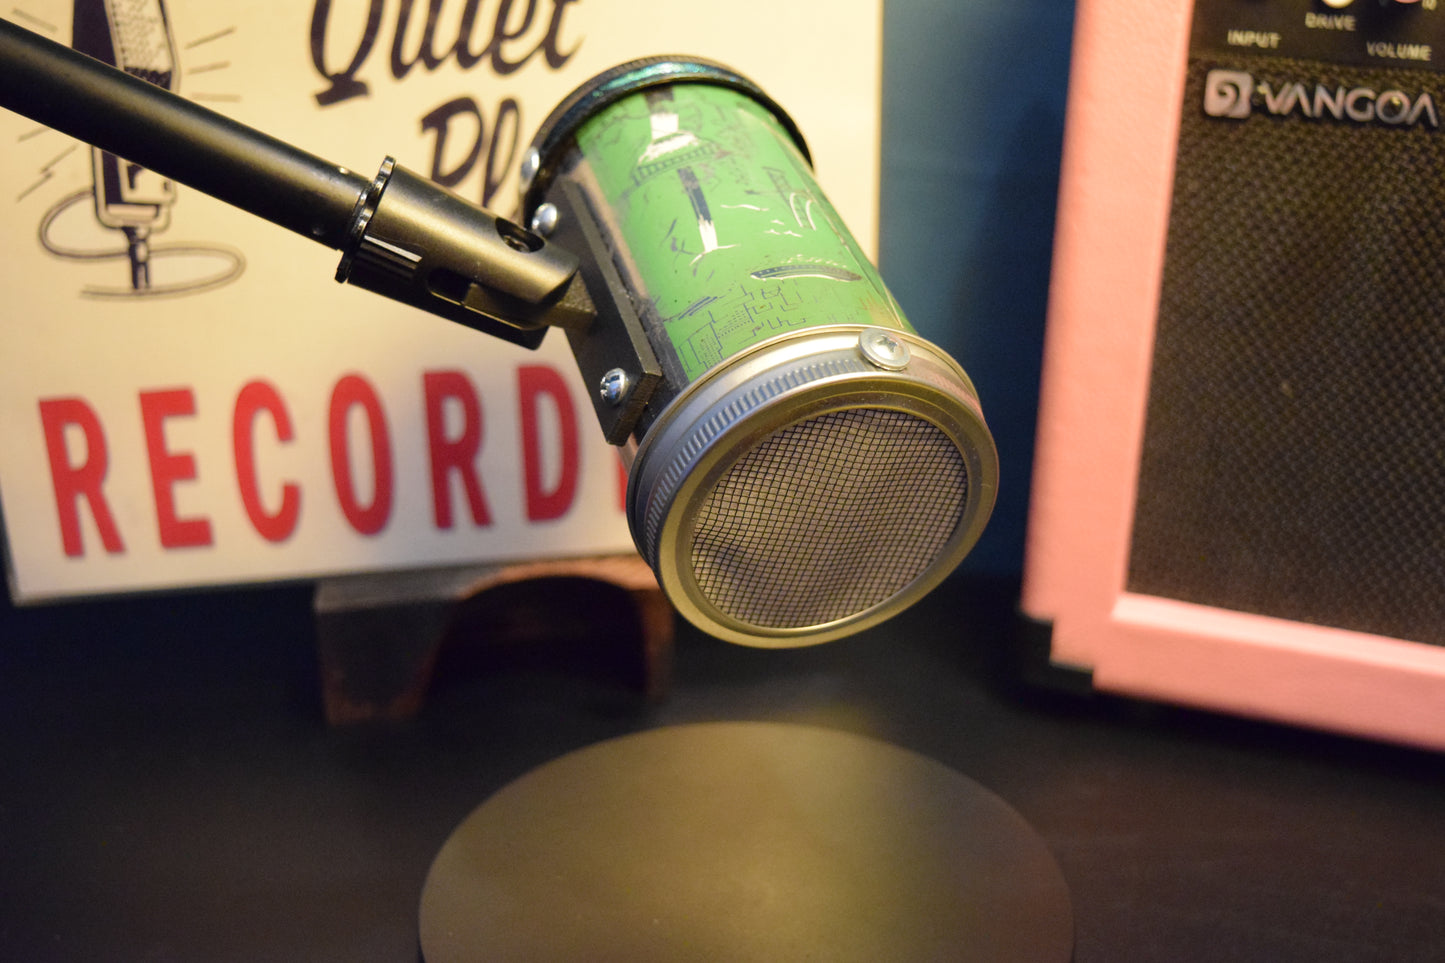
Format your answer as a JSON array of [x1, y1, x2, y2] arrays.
[[1022, 0, 1445, 749]]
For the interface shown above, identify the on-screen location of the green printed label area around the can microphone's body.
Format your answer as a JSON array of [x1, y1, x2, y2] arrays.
[[577, 84, 910, 380]]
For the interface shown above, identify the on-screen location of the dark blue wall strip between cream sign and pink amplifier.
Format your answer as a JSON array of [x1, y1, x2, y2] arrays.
[[879, 0, 1074, 573]]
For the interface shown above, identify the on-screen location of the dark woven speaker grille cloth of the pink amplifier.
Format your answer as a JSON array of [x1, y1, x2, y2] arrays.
[[1129, 58, 1445, 645]]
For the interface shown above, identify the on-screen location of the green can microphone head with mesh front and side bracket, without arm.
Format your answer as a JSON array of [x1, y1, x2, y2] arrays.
[[522, 58, 998, 646]]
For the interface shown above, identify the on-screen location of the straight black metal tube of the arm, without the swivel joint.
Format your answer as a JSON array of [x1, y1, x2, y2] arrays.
[[0, 20, 371, 249]]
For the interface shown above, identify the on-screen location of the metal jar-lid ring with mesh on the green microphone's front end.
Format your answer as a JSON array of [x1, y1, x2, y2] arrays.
[[627, 325, 998, 648]]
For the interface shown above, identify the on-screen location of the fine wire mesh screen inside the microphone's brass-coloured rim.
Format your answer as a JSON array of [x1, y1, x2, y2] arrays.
[[691, 408, 968, 629]]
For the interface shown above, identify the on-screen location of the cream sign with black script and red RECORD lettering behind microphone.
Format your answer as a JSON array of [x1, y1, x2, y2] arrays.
[[0, 0, 881, 602]]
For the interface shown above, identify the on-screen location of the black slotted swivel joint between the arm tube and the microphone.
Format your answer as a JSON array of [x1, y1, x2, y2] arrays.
[[337, 158, 597, 348]]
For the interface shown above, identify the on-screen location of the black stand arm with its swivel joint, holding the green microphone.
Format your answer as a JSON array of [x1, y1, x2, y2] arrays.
[[0, 20, 597, 347]]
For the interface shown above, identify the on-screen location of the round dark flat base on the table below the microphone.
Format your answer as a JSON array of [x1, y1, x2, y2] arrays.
[[420, 723, 1074, 963]]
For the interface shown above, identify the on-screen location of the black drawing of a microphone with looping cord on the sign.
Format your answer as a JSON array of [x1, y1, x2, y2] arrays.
[[28, 0, 246, 298]]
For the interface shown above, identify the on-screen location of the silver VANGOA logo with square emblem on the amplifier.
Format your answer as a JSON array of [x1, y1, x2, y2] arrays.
[[1204, 69, 1441, 130]]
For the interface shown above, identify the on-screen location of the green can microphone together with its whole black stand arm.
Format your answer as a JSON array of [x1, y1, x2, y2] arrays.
[[0, 20, 998, 646]]
